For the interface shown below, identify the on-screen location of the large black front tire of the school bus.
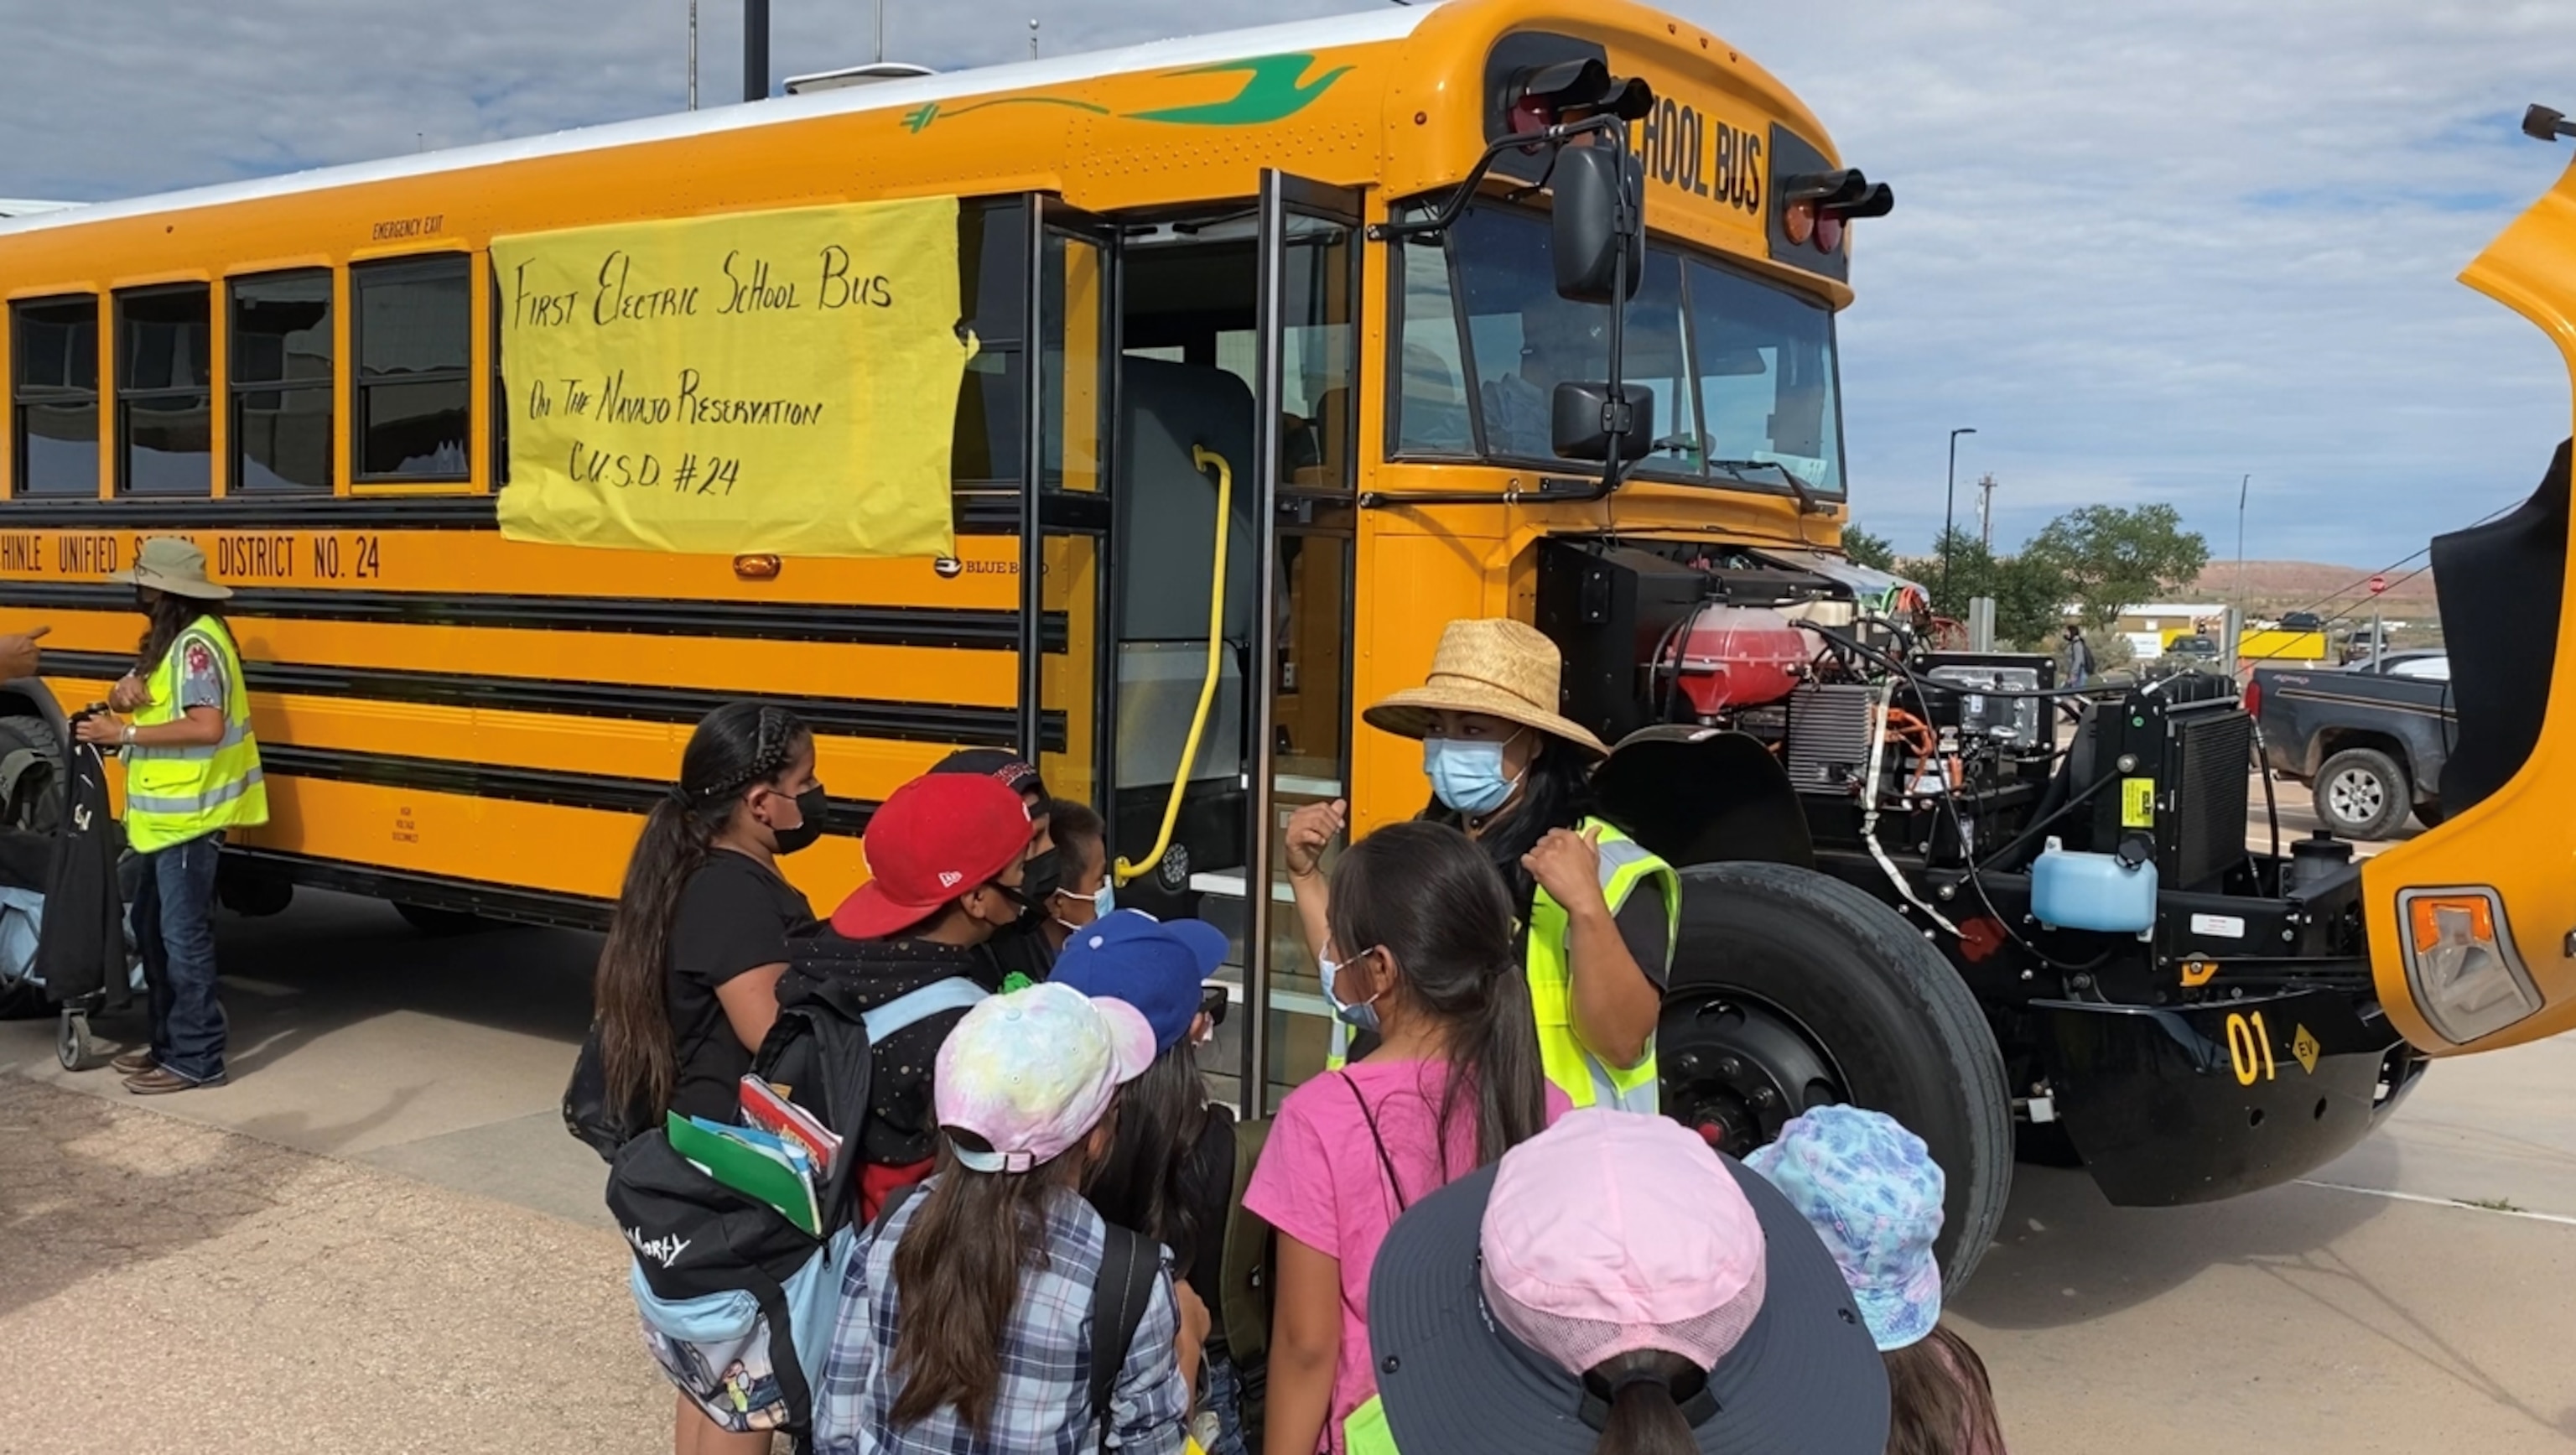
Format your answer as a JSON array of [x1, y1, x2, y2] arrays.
[[1656, 863, 2014, 1293]]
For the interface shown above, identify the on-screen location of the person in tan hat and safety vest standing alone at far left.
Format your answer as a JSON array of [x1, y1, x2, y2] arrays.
[[72, 536, 267, 1097]]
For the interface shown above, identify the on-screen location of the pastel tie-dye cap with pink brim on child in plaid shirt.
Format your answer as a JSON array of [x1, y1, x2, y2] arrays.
[[932, 984, 1154, 1172]]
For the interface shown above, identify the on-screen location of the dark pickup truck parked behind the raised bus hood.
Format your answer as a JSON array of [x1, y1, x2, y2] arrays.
[[2246, 652, 2458, 839]]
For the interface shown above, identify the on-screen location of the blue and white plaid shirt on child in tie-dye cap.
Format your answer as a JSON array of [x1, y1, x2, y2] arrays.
[[814, 1174, 1190, 1455]]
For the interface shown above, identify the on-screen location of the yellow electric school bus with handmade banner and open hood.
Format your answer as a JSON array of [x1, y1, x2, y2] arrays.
[[0, 0, 2576, 1280]]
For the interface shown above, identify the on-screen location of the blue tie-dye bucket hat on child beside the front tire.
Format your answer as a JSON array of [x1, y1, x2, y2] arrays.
[[1744, 1107, 1947, 1349]]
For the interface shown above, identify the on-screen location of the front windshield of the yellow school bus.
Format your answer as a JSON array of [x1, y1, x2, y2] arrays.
[[1396, 206, 1841, 495]]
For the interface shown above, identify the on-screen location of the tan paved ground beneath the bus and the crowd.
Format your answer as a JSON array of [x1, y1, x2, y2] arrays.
[[0, 876, 2576, 1455]]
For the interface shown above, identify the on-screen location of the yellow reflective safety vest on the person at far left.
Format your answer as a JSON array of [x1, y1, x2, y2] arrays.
[[127, 616, 267, 852]]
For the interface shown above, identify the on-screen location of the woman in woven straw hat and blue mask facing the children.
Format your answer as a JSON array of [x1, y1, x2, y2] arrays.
[[1285, 618, 1682, 1113]]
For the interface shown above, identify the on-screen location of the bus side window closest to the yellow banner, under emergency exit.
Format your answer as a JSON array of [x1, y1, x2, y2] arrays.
[[348, 252, 476, 481]]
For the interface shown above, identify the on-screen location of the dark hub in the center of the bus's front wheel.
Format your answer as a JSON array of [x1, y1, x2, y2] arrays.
[[1656, 991, 1845, 1159]]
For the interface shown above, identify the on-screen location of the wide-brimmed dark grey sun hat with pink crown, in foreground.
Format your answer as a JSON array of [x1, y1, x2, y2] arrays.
[[1368, 1107, 1888, 1455]]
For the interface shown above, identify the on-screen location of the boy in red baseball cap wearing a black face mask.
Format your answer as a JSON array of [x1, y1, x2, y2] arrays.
[[778, 772, 1031, 1218]]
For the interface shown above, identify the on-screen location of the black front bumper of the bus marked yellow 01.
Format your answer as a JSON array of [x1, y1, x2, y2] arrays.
[[2030, 989, 2424, 1208]]
